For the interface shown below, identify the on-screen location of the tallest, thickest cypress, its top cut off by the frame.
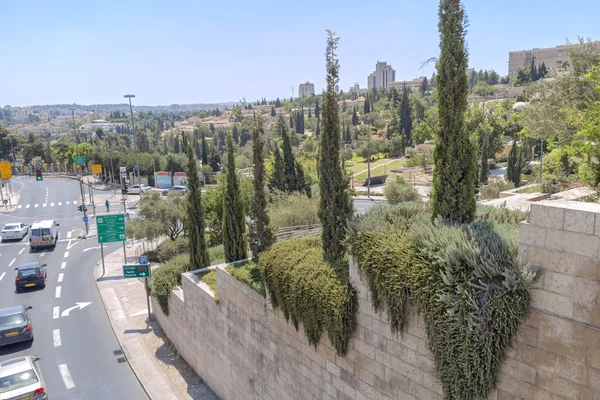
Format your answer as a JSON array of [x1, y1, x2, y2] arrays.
[[431, 0, 477, 222]]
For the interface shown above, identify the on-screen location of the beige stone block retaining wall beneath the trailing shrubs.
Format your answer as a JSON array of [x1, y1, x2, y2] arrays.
[[153, 202, 600, 400]]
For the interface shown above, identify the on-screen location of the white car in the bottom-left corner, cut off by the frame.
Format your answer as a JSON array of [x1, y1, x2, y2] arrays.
[[0, 356, 48, 400]]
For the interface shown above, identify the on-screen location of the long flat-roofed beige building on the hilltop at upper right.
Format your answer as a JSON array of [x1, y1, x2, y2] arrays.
[[508, 41, 600, 81]]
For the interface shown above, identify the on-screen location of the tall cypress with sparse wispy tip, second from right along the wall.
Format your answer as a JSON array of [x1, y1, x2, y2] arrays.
[[318, 30, 352, 260]]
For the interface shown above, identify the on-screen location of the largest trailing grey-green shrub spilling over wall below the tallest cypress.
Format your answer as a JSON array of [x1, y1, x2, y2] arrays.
[[349, 205, 533, 400]]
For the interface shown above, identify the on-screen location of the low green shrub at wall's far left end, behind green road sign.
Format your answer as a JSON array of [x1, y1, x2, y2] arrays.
[[150, 254, 190, 315]]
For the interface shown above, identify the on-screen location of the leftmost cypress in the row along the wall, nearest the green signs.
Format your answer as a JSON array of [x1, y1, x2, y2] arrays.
[[186, 134, 210, 271]]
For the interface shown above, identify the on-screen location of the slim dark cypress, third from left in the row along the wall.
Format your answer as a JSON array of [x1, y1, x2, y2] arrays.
[[249, 114, 275, 261]]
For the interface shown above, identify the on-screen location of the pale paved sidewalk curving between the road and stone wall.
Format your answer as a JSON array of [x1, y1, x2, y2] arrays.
[[94, 239, 218, 400]]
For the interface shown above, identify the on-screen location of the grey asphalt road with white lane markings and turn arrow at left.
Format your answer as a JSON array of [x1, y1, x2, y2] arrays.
[[0, 177, 148, 400]]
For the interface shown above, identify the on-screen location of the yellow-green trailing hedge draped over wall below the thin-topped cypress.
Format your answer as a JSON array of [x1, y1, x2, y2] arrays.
[[259, 237, 358, 355]]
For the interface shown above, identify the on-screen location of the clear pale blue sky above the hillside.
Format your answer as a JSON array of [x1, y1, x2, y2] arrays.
[[0, 0, 600, 107]]
